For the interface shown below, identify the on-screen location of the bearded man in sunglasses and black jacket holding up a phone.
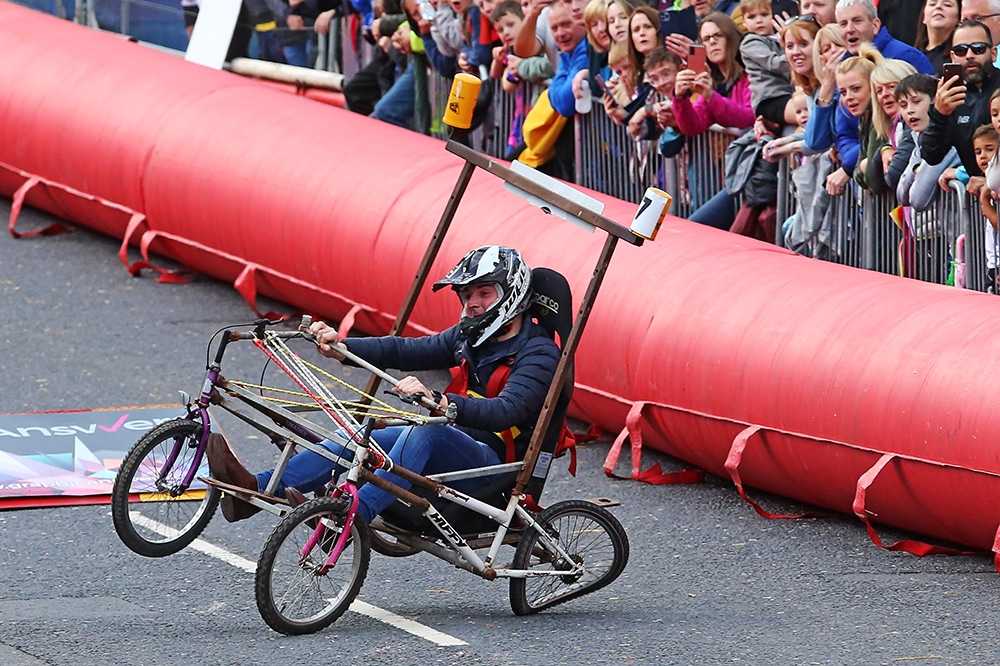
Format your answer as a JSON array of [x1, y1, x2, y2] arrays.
[[920, 20, 1000, 183]]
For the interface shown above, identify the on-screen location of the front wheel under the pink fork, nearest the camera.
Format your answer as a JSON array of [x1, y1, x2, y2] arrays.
[[254, 497, 371, 635]]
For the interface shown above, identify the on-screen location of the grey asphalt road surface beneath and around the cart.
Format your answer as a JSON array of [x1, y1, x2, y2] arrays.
[[0, 200, 1000, 666]]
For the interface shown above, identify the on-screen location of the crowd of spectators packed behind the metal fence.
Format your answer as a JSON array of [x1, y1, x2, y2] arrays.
[[195, 0, 1000, 289]]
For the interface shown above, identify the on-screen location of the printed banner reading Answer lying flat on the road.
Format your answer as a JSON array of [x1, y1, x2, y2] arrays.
[[0, 405, 184, 509]]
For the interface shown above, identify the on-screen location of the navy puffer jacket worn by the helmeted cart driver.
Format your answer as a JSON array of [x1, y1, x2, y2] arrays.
[[347, 320, 560, 460]]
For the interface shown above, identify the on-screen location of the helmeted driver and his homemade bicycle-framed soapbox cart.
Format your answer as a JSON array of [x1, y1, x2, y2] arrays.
[[105, 141, 641, 634]]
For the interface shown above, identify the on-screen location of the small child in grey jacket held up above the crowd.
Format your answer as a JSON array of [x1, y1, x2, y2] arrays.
[[740, 0, 795, 125]]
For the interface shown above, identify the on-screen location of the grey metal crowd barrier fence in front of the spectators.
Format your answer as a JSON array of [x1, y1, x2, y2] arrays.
[[18, 0, 1000, 291]]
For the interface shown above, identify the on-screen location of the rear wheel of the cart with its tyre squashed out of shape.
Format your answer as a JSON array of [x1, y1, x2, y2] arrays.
[[510, 500, 629, 615]]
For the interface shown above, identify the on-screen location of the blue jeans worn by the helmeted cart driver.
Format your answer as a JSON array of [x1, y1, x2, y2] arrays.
[[257, 425, 501, 522]]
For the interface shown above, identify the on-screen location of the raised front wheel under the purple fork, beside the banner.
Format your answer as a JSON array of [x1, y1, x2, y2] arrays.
[[111, 419, 220, 557]]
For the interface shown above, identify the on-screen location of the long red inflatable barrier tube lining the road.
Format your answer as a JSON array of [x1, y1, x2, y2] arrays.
[[0, 3, 1000, 552]]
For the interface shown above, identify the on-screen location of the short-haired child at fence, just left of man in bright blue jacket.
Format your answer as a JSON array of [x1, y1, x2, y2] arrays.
[[490, 0, 555, 158]]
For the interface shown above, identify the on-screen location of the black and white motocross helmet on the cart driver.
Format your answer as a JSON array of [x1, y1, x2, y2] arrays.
[[433, 245, 532, 347]]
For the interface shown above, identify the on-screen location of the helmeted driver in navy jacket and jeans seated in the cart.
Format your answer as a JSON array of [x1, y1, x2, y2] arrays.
[[208, 245, 560, 522]]
